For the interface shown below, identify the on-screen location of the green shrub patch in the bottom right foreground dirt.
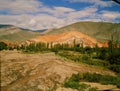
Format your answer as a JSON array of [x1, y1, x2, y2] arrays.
[[64, 73, 120, 91]]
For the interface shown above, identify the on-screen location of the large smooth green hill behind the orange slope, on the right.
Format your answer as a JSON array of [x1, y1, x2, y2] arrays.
[[47, 22, 120, 41]]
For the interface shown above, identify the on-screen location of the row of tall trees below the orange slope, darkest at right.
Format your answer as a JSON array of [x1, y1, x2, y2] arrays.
[[0, 39, 120, 72]]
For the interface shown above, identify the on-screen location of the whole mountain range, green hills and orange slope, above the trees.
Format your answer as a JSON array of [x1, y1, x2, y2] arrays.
[[0, 21, 120, 47]]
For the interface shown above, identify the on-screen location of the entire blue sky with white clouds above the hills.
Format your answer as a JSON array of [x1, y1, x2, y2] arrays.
[[0, 0, 120, 30]]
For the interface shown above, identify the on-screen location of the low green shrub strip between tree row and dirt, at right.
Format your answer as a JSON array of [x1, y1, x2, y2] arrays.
[[58, 48, 120, 73]]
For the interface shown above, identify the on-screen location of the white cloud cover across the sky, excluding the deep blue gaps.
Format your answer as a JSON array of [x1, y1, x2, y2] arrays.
[[0, 0, 120, 30]]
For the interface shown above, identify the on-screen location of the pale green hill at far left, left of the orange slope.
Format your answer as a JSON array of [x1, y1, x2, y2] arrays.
[[0, 25, 40, 42]]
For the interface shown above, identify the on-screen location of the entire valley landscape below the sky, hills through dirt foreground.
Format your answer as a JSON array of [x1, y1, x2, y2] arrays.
[[0, 22, 120, 91]]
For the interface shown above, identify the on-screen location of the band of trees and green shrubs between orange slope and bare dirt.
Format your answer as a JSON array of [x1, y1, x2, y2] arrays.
[[1, 35, 120, 73]]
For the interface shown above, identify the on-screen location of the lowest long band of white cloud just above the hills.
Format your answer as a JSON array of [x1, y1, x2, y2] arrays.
[[0, 7, 120, 30]]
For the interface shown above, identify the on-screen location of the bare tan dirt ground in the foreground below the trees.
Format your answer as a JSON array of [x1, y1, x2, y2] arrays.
[[0, 50, 115, 91]]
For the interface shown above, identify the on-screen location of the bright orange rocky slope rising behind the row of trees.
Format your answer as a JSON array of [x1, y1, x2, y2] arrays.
[[28, 31, 103, 47]]
